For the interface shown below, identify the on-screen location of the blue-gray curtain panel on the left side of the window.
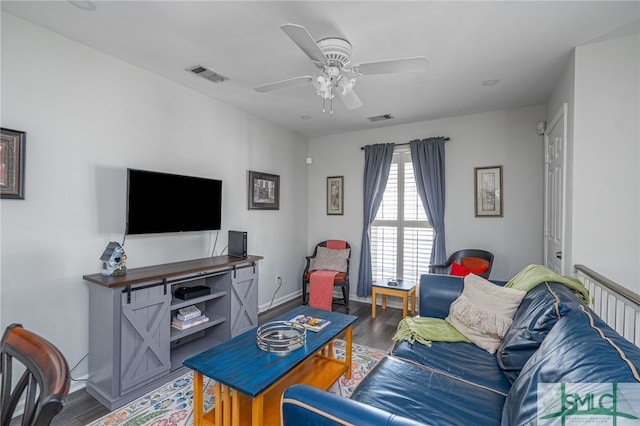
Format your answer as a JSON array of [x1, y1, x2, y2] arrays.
[[357, 143, 394, 297]]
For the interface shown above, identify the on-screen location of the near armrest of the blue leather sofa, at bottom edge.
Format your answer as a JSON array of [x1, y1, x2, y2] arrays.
[[282, 385, 421, 426]]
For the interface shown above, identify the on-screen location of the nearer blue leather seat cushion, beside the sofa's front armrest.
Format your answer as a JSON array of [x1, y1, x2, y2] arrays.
[[351, 357, 505, 426]]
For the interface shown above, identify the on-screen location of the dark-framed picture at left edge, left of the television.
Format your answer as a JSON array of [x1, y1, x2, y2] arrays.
[[0, 128, 26, 200]]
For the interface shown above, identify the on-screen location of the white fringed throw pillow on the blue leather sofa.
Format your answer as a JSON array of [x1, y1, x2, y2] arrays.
[[445, 274, 527, 354]]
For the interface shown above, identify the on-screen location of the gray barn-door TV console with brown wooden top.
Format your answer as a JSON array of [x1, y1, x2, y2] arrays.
[[82, 256, 262, 410]]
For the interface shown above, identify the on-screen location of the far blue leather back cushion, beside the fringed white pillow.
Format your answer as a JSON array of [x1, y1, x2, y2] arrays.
[[496, 282, 583, 383]]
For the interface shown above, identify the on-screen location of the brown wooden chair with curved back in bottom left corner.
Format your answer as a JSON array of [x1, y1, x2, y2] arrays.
[[0, 324, 70, 426]]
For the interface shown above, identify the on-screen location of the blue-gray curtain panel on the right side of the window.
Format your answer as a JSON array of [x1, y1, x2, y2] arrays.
[[409, 137, 447, 264]]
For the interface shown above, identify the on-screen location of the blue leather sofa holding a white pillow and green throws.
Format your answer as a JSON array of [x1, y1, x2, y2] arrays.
[[282, 275, 640, 426]]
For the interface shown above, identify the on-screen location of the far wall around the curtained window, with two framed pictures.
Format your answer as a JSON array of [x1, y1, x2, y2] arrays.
[[308, 105, 545, 286]]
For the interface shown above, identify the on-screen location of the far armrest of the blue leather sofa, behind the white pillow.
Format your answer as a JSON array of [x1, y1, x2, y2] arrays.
[[420, 274, 507, 318]]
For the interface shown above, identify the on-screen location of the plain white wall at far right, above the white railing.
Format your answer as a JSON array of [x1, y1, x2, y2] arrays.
[[547, 34, 640, 293]]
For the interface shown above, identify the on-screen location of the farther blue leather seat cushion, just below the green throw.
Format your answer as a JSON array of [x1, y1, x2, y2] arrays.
[[391, 341, 511, 393]]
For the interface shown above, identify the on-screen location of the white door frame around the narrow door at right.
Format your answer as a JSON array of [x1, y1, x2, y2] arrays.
[[543, 102, 569, 275]]
